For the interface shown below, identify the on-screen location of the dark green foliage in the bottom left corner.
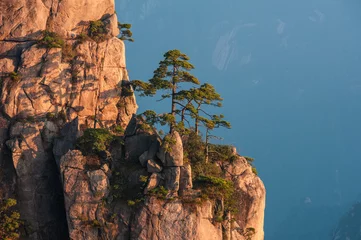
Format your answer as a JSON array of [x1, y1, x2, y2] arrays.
[[0, 198, 21, 240]]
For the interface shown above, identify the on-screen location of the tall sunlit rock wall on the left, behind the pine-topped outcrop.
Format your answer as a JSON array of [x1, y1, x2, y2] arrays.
[[0, 0, 137, 239]]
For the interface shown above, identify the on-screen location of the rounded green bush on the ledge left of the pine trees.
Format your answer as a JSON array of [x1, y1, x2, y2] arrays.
[[76, 128, 114, 155]]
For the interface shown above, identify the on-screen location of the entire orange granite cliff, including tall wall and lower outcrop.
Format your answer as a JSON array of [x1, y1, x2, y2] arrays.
[[0, 0, 265, 240]]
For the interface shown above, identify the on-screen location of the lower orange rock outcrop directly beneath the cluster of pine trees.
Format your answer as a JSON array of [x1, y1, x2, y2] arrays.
[[61, 131, 265, 240]]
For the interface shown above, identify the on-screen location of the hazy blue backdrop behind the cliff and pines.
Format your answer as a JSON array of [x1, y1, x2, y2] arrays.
[[116, 0, 361, 240]]
